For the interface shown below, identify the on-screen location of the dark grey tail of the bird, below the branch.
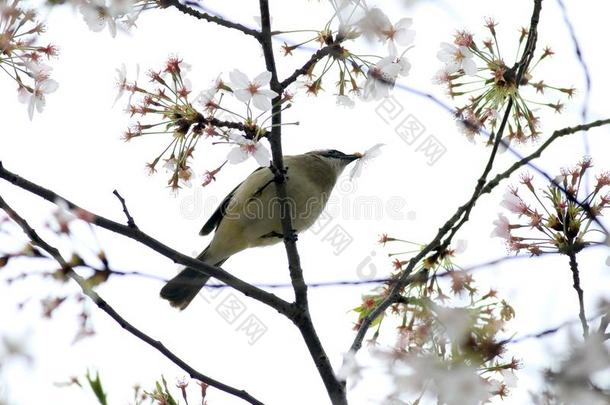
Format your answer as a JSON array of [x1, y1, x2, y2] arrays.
[[161, 249, 226, 310]]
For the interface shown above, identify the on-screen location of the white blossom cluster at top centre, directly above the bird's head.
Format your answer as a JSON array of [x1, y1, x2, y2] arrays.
[[283, 0, 415, 107]]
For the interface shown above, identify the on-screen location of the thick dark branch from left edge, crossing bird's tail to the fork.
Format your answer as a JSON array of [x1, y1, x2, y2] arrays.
[[0, 161, 294, 316]]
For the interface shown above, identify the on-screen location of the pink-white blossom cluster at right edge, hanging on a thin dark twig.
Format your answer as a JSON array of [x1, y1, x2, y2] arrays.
[[492, 157, 610, 255]]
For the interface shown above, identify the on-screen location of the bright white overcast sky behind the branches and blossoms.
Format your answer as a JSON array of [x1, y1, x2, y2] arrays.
[[0, 0, 610, 405]]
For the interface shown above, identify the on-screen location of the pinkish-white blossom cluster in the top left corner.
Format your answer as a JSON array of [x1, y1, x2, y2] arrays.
[[0, 0, 58, 119]]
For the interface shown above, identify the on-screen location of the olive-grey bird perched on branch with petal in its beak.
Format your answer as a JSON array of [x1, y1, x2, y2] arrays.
[[160, 149, 363, 310]]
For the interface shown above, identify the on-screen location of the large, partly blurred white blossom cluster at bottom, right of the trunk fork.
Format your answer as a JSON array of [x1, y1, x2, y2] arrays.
[[355, 235, 519, 404]]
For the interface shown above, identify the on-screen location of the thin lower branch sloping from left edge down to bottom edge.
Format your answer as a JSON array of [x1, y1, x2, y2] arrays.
[[0, 196, 264, 405]]
